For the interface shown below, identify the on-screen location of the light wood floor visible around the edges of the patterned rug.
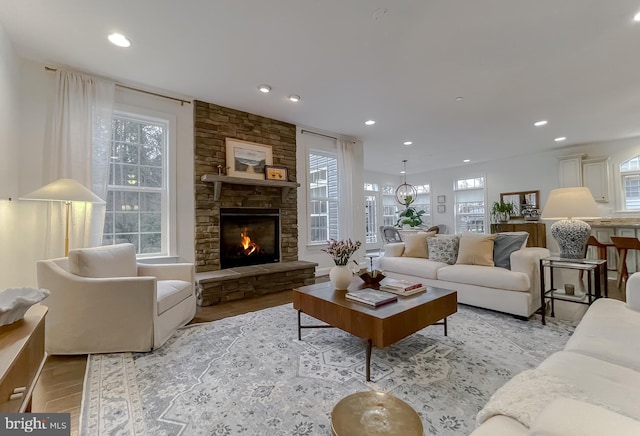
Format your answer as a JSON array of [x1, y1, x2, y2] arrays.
[[32, 280, 623, 436]]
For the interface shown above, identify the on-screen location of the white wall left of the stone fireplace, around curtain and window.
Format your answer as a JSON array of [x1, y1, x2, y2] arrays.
[[0, 52, 195, 290]]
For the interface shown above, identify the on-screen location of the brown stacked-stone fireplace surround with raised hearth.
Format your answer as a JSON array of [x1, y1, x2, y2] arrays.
[[194, 101, 317, 306]]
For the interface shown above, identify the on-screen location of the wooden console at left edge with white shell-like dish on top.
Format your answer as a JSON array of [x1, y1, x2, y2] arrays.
[[0, 304, 47, 413]]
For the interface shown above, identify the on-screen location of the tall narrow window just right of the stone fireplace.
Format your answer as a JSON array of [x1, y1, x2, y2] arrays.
[[309, 151, 339, 244]]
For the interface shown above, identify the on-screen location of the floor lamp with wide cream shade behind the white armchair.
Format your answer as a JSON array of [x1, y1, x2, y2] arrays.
[[20, 179, 105, 257]]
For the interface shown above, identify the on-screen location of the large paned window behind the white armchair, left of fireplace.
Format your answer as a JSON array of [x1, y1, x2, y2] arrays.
[[102, 112, 169, 254]]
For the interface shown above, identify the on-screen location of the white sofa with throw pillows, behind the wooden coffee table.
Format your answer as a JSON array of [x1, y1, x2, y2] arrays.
[[379, 232, 550, 317]]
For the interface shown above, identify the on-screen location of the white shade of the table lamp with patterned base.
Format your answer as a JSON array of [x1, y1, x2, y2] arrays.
[[541, 187, 601, 220]]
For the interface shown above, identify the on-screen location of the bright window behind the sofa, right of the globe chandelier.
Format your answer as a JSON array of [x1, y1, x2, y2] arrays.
[[453, 177, 485, 233]]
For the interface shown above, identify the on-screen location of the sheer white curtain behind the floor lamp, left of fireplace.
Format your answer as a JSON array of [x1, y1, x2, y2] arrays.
[[43, 69, 115, 257]]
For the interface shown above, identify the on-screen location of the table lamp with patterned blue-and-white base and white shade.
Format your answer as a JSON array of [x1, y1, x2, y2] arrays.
[[542, 187, 601, 259]]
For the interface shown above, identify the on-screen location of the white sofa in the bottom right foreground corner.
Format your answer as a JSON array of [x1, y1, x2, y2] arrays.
[[472, 273, 640, 436]]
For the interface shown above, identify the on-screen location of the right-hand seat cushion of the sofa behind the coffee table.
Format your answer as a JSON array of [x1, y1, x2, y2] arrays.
[[438, 264, 531, 292]]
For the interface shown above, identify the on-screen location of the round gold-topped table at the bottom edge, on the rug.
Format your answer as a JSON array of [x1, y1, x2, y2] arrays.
[[331, 391, 424, 436]]
